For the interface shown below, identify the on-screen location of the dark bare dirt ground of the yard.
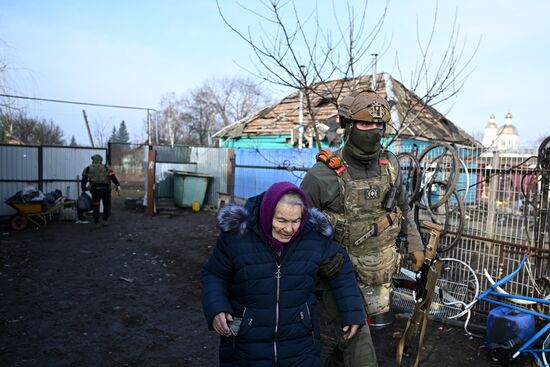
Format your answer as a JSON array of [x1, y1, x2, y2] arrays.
[[0, 197, 532, 367]]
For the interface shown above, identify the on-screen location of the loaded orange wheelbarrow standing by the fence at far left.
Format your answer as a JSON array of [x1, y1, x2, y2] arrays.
[[6, 196, 67, 231]]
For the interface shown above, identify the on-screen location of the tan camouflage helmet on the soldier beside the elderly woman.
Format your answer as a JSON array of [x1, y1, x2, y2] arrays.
[[338, 90, 391, 127]]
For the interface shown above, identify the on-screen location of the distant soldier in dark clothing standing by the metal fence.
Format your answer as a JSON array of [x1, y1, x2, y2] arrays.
[[80, 154, 120, 227]]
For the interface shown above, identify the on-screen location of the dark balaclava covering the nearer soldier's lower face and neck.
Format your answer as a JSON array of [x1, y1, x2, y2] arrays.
[[344, 123, 384, 162]]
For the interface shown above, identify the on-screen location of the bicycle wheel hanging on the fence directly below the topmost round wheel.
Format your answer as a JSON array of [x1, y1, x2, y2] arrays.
[[414, 181, 466, 253]]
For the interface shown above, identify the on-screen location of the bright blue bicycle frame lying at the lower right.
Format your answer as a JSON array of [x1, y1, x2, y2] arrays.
[[478, 255, 550, 362]]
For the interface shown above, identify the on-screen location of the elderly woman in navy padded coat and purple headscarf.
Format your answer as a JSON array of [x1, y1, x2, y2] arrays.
[[202, 182, 365, 367]]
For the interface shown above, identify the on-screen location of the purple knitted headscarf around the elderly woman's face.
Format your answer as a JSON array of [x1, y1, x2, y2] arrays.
[[260, 181, 307, 252]]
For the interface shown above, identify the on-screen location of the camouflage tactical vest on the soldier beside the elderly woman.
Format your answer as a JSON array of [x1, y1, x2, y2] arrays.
[[325, 151, 401, 257]]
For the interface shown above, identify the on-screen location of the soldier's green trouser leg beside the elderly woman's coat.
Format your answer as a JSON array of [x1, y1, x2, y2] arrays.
[[321, 281, 378, 367]]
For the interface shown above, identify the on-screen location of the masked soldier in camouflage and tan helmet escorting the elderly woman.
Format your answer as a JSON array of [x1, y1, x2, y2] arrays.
[[301, 90, 424, 367]]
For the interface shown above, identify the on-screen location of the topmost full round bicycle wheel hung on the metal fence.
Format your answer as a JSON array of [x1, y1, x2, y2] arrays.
[[418, 143, 460, 209]]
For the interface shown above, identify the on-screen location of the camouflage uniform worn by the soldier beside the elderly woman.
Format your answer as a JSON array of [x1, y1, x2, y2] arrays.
[[301, 150, 422, 367]]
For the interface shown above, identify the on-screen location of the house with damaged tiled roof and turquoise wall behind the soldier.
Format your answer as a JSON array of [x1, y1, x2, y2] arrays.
[[212, 73, 480, 150]]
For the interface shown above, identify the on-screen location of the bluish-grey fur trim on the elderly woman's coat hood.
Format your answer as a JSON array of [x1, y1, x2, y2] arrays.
[[217, 204, 333, 237]]
